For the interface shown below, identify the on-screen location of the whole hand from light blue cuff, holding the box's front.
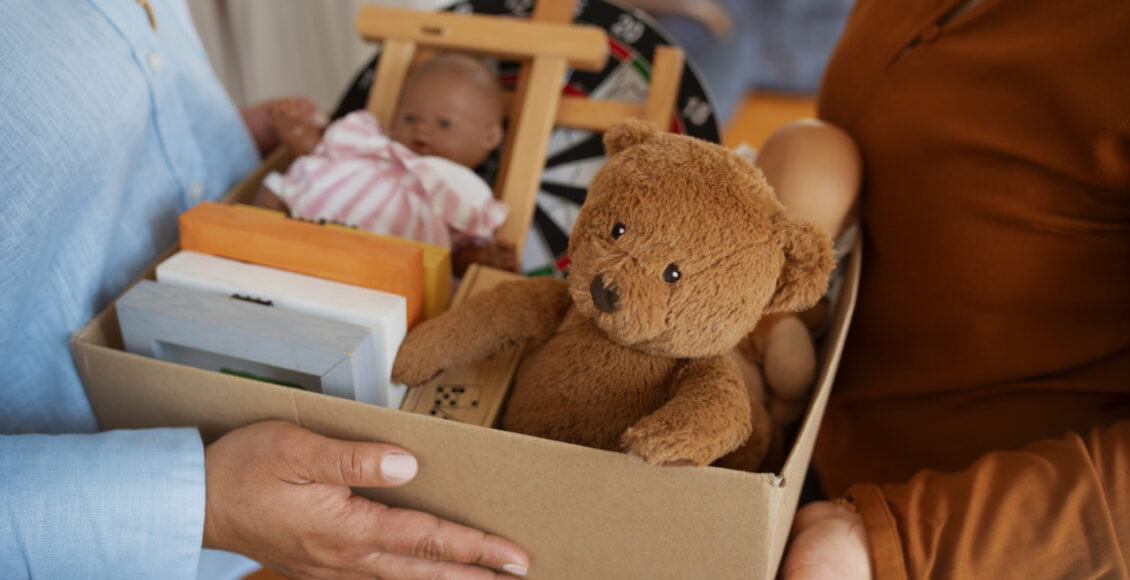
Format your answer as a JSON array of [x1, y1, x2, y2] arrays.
[[203, 422, 529, 579]]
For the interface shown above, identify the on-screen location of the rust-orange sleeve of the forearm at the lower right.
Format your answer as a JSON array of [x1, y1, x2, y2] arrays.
[[848, 421, 1130, 580]]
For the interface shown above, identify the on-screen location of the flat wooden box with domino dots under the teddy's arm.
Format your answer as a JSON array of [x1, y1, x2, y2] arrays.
[[400, 263, 525, 427]]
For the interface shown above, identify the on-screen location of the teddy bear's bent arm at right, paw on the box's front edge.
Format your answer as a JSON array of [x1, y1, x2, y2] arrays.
[[620, 356, 753, 465]]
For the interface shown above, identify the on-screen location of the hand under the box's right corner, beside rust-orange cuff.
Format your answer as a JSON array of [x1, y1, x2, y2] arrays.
[[781, 502, 871, 580]]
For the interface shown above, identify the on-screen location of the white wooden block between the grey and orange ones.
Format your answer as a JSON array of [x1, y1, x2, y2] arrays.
[[157, 250, 407, 408]]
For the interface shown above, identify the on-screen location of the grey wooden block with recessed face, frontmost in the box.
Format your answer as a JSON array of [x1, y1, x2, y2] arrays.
[[116, 280, 380, 399]]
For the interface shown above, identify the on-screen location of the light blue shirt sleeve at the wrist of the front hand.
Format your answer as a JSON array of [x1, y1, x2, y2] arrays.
[[0, 428, 205, 579]]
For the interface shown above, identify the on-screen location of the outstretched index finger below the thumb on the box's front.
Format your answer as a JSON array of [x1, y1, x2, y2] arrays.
[[357, 503, 530, 575]]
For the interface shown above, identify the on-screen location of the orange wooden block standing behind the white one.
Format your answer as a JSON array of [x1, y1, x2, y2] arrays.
[[180, 202, 424, 328]]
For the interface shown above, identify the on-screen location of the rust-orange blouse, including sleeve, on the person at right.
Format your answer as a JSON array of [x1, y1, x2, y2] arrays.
[[814, 0, 1130, 579]]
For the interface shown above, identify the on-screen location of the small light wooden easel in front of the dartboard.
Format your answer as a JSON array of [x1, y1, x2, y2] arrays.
[[356, 0, 684, 260]]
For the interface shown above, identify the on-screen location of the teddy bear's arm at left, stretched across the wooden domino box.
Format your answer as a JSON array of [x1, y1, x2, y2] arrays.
[[392, 278, 573, 387]]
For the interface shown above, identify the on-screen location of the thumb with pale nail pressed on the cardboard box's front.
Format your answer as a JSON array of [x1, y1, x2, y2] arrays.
[[287, 431, 418, 487]]
